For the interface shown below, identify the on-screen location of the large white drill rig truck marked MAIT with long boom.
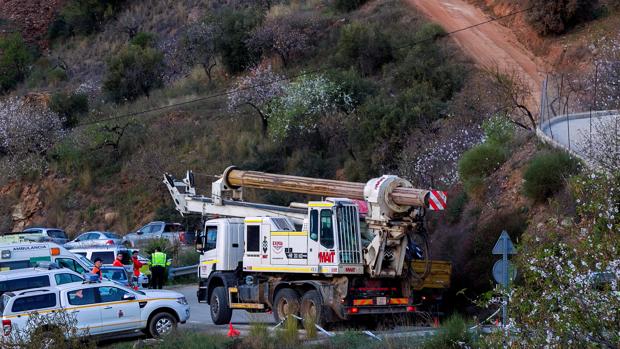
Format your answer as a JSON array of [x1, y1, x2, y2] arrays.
[[164, 166, 446, 324]]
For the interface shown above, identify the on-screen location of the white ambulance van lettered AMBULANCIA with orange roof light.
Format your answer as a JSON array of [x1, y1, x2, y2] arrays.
[[0, 242, 90, 274]]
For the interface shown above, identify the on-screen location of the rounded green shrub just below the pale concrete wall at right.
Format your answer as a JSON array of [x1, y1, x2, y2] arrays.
[[523, 151, 579, 201]]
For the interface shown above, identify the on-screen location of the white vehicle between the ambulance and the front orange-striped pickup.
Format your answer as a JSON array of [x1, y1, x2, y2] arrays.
[[0, 262, 84, 296]]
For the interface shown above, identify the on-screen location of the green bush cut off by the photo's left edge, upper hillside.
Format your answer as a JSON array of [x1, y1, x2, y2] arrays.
[[0, 33, 33, 93]]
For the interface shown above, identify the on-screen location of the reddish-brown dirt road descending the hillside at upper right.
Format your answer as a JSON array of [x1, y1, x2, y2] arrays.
[[406, 0, 543, 111]]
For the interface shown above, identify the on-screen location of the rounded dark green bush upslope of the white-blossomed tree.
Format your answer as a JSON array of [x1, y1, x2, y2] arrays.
[[334, 22, 394, 75]]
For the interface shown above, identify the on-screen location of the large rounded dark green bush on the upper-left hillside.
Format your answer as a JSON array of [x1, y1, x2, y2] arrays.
[[103, 45, 164, 103]]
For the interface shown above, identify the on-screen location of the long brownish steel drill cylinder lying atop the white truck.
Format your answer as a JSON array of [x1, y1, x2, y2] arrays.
[[223, 168, 429, 207]]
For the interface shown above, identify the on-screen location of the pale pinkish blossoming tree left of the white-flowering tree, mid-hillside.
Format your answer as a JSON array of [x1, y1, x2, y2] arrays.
[[228, 65, 286, 133]]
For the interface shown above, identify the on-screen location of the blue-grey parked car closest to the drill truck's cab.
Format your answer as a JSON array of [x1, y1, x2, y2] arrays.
[[123, 221, 194, 247]]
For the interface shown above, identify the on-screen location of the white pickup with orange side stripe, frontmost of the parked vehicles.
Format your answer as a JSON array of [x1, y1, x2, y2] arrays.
[[0, 281, 189, 340]]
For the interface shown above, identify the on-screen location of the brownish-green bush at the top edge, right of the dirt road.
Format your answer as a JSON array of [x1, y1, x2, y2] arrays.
[[526, 0, 598, 35]]
